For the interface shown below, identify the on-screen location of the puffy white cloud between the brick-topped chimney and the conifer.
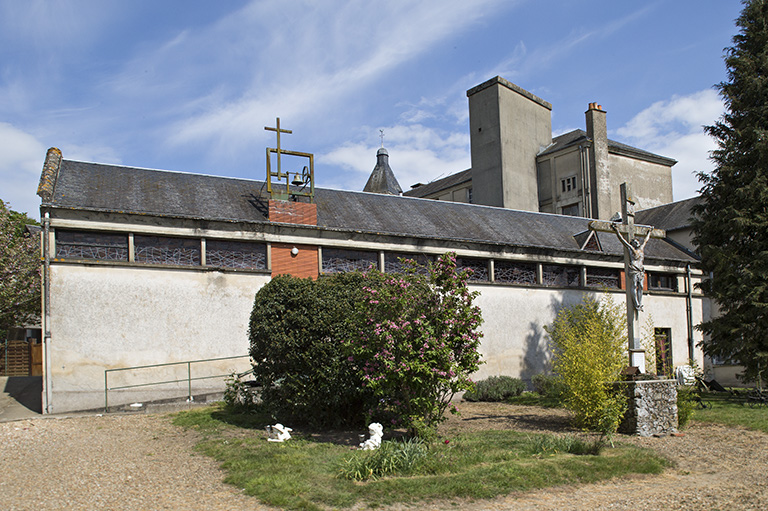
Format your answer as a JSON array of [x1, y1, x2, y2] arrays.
[[616, 89, 724, 200]]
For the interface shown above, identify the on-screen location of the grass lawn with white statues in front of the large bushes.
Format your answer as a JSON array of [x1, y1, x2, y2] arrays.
[[174, 407, 667, 509]]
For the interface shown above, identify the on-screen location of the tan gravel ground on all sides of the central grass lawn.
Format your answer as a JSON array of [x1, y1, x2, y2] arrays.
[[0, 403, 768, 511]]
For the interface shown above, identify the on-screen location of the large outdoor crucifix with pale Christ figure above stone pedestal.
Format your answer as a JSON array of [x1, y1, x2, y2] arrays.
[[589, 183, 667, 373]]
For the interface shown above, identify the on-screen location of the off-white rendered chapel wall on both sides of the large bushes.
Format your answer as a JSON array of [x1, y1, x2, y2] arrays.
[[50, 264, 702, 413]]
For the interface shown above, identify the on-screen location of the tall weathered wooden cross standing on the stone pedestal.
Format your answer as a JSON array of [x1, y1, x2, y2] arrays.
[[589, 183, 667, 373]]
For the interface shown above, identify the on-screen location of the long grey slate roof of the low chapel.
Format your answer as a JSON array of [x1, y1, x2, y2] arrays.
[[46, 160, 693, 262]]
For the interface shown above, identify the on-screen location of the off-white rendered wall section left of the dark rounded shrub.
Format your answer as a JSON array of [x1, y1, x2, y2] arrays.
[[49, 264, 269, 413]]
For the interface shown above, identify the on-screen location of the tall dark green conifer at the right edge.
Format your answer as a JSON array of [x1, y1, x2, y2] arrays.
[[693, 0, 768, 380]]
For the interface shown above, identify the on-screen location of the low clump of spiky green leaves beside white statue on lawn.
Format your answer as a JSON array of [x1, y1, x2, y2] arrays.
[[339, 438, 429, 481]]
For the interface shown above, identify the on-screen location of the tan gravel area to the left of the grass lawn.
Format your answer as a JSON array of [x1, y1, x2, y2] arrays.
[[0, 414, 267, 511]]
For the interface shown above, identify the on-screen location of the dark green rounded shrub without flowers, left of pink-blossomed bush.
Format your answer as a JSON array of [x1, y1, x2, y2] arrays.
[[248, 273, 371, 427]]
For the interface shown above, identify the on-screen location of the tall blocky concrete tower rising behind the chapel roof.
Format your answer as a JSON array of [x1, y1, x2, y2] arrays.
[[467, 76, 552, 211]]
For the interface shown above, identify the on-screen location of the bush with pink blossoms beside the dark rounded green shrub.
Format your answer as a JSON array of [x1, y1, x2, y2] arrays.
[[348, 254, 482, 438]]
